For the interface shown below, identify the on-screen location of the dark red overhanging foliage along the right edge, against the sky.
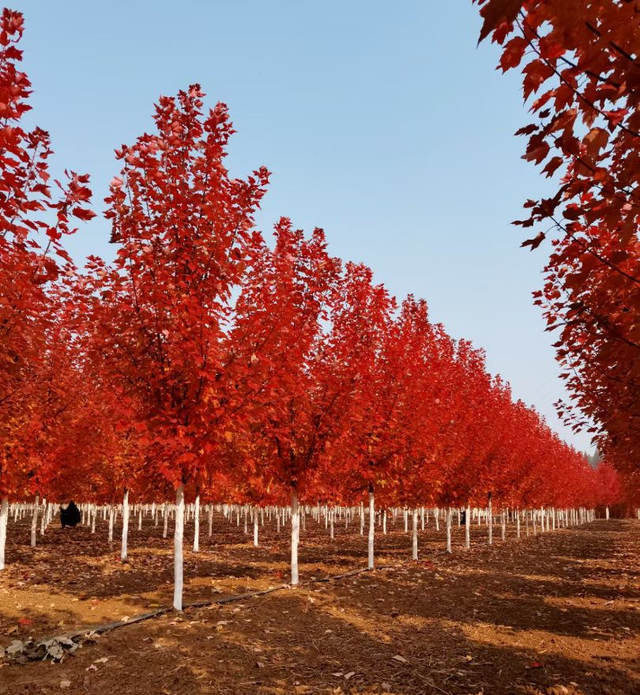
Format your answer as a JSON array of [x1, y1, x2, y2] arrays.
[[478, 0, 640, 473]]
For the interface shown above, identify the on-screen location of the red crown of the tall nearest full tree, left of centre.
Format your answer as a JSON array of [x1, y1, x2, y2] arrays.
[[89, 85, 269, 492]]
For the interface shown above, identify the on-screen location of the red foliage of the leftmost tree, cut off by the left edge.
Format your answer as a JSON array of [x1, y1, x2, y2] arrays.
[[0, 9, 94, 494]]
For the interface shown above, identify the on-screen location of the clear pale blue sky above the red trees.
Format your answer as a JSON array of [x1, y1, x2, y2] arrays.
[[11, 0, 590, 450]]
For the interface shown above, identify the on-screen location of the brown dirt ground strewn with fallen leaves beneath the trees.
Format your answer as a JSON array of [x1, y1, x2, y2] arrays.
[[0, 508, 640, 695]]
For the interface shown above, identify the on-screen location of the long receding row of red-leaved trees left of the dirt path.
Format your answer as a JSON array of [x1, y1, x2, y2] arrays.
[[0, 10, 618, 607]]
